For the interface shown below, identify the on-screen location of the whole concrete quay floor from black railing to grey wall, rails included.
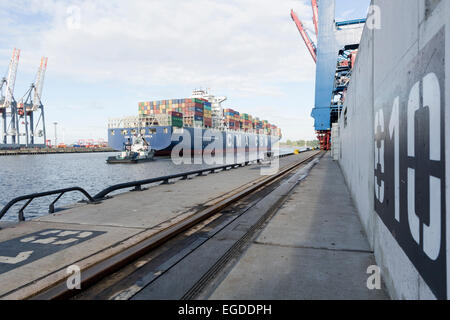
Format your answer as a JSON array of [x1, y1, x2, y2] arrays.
[[0, 151, 387, 299]]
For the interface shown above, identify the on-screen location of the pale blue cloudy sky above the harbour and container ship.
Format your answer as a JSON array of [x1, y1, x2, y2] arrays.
[[0, 0, 370, 143]]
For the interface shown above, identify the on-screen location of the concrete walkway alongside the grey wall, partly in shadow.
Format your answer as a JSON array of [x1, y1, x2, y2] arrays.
[[209, 155, 389, 300]]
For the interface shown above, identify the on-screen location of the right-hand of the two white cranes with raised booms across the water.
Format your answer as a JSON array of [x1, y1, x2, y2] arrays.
[[18, 57, 48, 146]]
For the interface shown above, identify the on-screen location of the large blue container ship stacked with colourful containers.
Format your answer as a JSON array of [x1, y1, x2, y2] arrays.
[[108, 89, 281, 156]]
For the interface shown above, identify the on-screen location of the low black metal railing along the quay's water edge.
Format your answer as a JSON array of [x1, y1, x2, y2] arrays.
[[0, 150, 302, 221]]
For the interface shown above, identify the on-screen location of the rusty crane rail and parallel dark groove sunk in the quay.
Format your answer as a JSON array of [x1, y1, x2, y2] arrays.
[[31, 151, 322, 300]]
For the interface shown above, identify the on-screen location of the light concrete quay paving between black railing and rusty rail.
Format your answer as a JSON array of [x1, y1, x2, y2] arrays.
[[0, 153, 311, 299]]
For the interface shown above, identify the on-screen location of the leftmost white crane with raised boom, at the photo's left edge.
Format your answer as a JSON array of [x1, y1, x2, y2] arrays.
[[0, 48, 20, 145]]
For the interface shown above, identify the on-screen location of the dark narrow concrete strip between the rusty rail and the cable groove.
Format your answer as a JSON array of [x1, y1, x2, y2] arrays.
[[133, 160, 318, 300]]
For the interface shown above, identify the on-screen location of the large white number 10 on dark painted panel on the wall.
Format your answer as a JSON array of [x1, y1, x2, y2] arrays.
[[374, 29, 447, 298]]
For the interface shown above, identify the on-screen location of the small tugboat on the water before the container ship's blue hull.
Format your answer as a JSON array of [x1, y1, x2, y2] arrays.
[[106, 135, 155, 164]]
